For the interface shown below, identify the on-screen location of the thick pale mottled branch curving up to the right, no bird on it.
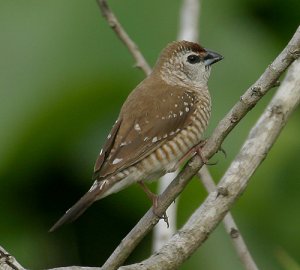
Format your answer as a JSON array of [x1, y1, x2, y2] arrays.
[[119, 60, 300, 270]]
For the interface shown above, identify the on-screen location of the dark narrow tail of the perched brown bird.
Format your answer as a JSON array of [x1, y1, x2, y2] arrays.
[[49, 181, 104, 232]]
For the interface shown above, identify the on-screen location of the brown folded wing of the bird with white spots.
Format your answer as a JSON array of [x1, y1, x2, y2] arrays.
[[94, 77, 204, 180]]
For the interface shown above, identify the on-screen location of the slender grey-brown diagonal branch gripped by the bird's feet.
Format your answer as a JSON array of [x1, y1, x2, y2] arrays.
[[103, 27, 300, 269]]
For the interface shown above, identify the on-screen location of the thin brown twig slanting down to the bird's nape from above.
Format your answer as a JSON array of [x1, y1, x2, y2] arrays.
[[97, 0, 151, 75]]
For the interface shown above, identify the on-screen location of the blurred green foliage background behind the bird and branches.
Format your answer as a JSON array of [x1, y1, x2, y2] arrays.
[[0, 0, 300, 270]]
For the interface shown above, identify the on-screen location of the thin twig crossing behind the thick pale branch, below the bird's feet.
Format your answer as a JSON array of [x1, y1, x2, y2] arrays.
[[198, 165, 258, 270]]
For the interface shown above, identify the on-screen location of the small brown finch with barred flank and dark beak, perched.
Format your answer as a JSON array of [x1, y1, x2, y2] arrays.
[[50, 40, 223, 232]]
